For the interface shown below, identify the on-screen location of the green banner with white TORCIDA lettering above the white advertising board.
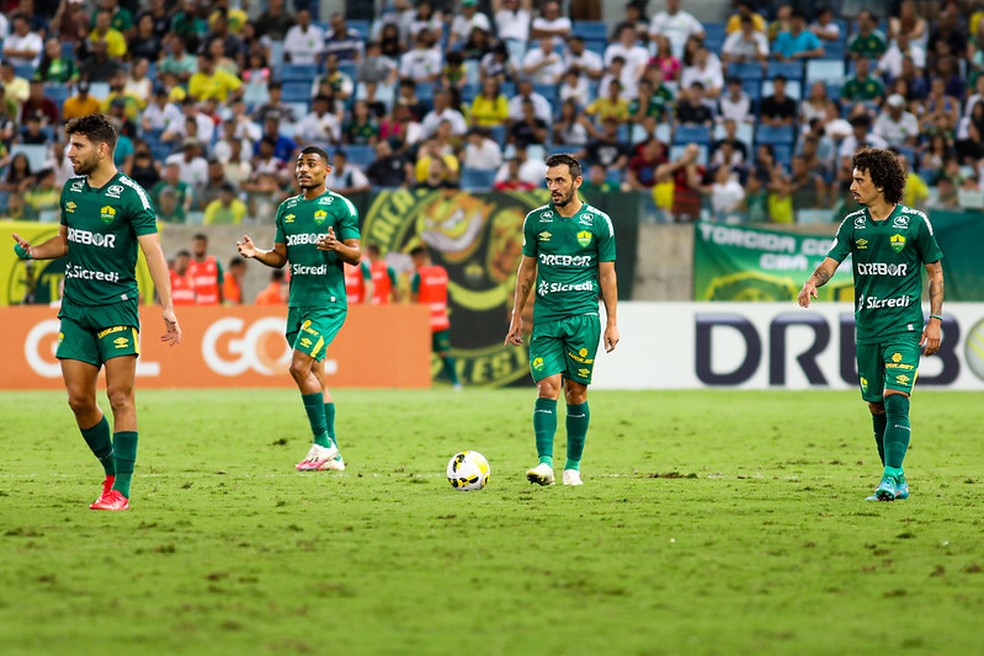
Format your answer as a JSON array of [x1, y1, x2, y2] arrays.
[[694, 222, 854, 301]]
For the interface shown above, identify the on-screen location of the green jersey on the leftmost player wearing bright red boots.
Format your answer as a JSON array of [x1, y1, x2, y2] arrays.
[[60, 173, 157, 305]]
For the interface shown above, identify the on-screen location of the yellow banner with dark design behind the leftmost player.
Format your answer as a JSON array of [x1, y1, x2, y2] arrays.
[[0, 221, 154, 306]]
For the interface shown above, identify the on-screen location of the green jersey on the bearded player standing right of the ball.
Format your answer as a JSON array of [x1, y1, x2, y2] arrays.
[[523, 203, 615, 323]]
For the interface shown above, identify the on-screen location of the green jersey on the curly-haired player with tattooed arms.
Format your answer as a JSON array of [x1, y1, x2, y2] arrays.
[[827, 204, 943, 344]]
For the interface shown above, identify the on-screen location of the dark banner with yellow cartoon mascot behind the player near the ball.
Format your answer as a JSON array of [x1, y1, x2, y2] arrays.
[[360, 189, 638, 386]]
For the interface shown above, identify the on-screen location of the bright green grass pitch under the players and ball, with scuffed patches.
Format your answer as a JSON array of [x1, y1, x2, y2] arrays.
[[0, 389, 984, 655]]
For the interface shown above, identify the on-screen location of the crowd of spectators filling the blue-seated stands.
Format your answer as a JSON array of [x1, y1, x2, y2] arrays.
[[0, 0, 984, 231]]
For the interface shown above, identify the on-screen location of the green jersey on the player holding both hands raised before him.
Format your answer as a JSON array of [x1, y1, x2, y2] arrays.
[[274, 191, 359, 308]]
